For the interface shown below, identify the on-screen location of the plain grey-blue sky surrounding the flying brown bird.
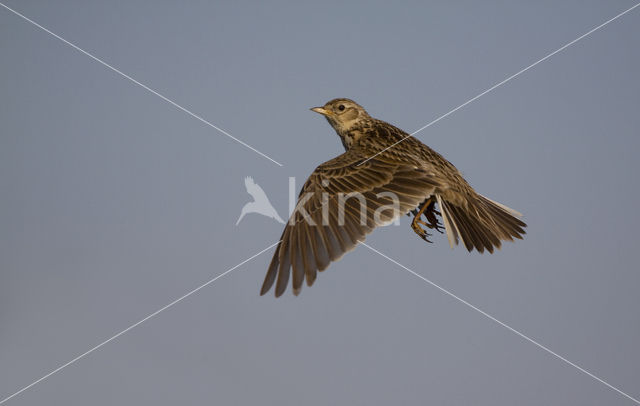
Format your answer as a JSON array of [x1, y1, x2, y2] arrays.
[[0, 0, 640, 405]]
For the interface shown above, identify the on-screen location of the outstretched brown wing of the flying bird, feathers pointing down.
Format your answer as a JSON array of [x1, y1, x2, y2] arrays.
[[260, 149, 438, 297]]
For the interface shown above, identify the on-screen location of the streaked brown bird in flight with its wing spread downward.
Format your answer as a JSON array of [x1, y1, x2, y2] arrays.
[[260, 98, 526, 297]]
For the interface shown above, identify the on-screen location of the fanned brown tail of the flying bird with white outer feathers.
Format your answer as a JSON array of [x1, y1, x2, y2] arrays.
[[436, 193, 527, 253]]
